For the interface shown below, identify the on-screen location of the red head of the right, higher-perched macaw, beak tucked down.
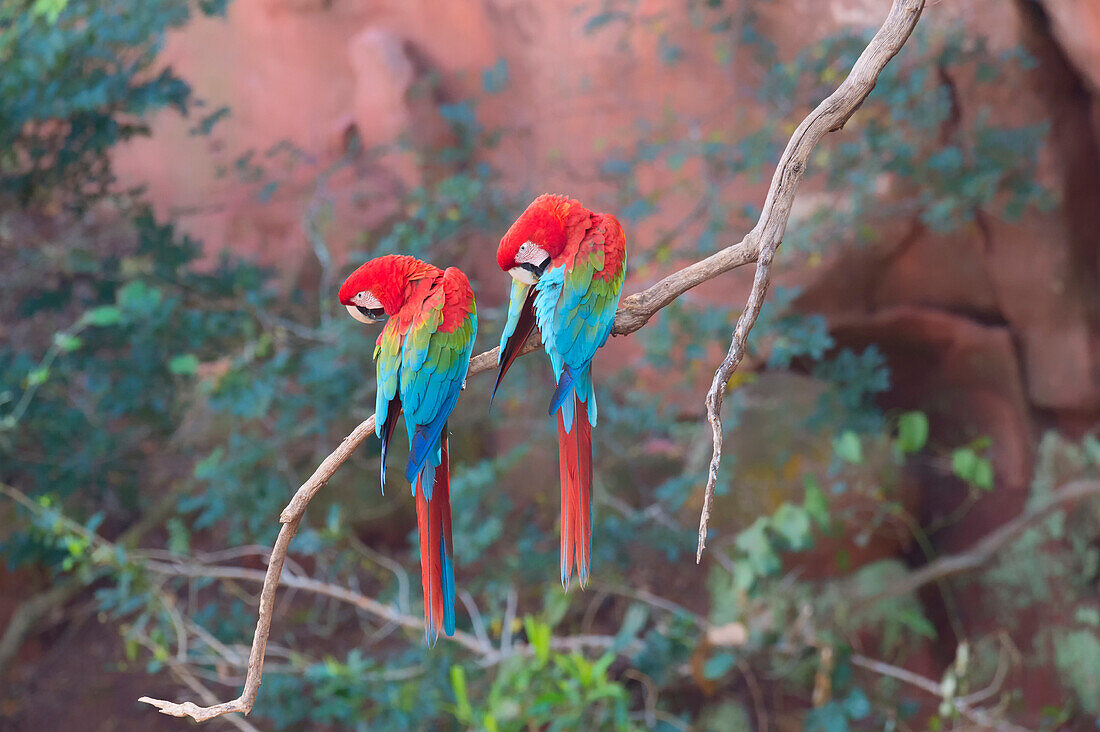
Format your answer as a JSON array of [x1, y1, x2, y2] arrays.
[[496, 194, 590, 285]]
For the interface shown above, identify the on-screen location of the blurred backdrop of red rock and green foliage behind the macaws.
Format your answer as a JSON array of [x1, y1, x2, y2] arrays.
[[0, 0, 1100, 732]]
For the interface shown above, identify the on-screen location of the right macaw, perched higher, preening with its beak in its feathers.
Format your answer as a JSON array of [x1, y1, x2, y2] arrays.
[[490, 194, 626, 589]]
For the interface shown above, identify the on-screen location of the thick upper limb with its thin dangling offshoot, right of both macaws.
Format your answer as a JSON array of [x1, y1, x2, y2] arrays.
[[695, 0, 924, 562]]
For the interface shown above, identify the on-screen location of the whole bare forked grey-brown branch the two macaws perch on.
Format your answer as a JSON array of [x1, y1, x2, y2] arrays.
[[140, 0, 924, 722]]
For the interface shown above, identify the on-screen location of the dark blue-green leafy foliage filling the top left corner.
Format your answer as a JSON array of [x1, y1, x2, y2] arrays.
[[0, 0, 226, 203]]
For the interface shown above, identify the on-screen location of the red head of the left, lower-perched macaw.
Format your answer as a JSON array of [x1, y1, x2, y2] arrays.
[[340, 254, 439, 323]]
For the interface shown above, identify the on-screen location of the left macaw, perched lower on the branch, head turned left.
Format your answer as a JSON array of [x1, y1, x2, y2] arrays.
[[340, 254, 477, 645]]
